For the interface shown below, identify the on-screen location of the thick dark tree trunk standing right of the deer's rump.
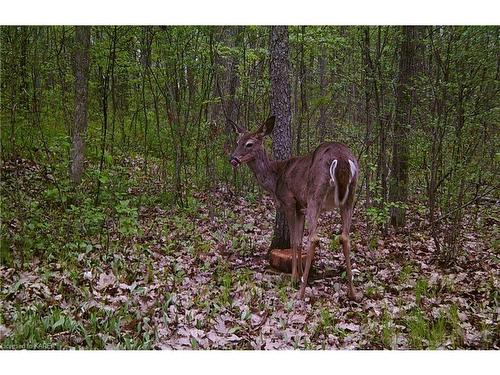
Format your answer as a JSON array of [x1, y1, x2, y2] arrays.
[[389, 26, 416, 227]]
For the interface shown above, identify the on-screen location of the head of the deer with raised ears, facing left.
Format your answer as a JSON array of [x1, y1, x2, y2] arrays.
[[228, 116, 275, 168]]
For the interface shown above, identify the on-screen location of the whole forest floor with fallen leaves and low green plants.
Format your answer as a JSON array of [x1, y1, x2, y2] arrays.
[[0, 155, 500, 349]]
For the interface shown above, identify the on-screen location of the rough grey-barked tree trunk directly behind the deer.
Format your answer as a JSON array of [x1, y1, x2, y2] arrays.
[[269, 26, 292, 249]]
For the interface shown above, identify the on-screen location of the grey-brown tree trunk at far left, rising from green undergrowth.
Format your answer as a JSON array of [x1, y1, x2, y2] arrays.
[[70, 26, 90, 184]]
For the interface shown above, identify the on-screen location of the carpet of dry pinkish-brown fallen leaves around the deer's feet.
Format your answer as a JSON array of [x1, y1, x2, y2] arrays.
[[0, 158, 500, 350]]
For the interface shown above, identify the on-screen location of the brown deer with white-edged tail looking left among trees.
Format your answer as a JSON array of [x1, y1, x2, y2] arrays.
[[228, 116, 361, 300]]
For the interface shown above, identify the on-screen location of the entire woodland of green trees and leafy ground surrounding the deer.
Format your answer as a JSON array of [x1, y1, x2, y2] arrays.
[[0, 26, 500, 349]]
